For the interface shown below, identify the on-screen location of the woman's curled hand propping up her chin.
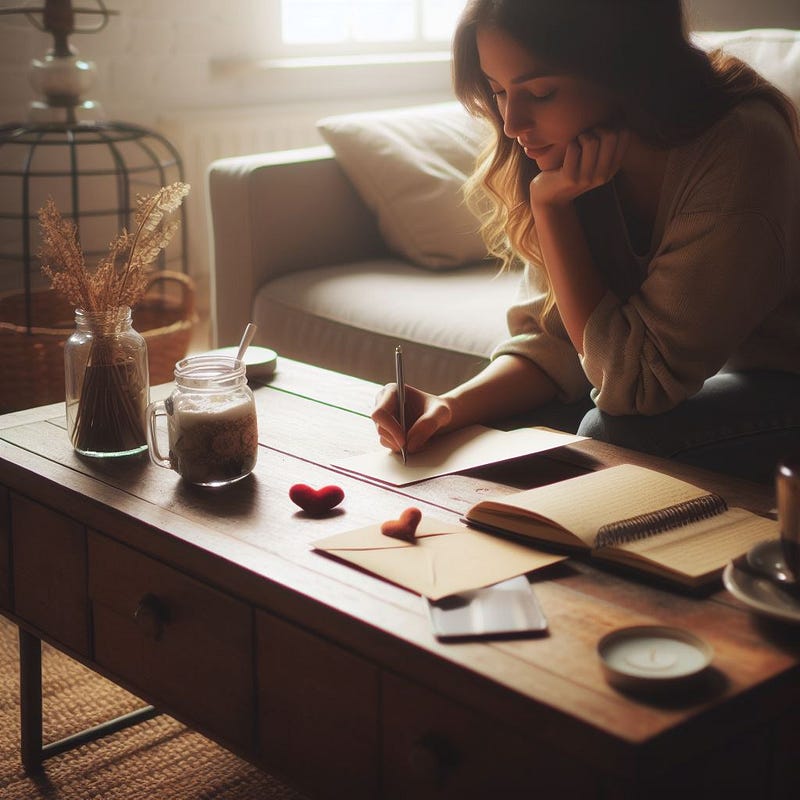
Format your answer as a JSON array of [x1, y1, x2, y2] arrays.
[[530, 128, 630, 209]]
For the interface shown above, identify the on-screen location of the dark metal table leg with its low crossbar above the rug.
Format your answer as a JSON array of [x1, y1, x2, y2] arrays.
[[19, 628, 160, 773]]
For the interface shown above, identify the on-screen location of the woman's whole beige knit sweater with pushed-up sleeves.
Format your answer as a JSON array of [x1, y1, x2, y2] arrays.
[[494, 101, 800, 414]]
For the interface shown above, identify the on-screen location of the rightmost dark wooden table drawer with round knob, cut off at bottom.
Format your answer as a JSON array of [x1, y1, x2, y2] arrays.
[[381, 673, 599, 800]]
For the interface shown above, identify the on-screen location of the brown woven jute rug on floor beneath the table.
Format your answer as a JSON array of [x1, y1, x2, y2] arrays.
[[0, 617, 303, 800]]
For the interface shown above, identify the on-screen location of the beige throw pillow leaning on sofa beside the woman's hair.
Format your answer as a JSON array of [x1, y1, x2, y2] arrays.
[[317, 102, 486, 269]]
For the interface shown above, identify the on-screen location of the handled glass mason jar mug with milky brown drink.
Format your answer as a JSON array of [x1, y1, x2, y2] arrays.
[[147, 355, 258, 486]]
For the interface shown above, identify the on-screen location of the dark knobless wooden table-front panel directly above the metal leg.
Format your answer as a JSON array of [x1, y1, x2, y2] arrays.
[[10, 493, 90, 656]]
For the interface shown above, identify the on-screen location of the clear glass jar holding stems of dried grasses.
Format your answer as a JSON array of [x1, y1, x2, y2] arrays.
[[64, 306, 150, 458]]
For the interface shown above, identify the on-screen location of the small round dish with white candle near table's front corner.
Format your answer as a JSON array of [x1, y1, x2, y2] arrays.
[[597, 625, 713, 690]]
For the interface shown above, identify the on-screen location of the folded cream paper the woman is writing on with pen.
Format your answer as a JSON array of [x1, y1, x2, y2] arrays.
[[333, 425, 586, 486]]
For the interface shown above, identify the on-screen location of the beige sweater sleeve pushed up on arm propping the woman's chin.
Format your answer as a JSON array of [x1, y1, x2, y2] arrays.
[[581, 212, 787, 414]]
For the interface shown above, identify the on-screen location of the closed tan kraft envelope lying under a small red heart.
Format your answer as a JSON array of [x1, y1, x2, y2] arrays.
[[313, 518, 566, 600]]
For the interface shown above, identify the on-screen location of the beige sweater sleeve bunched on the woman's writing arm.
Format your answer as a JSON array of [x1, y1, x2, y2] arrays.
[[492, 264, 590, 402]]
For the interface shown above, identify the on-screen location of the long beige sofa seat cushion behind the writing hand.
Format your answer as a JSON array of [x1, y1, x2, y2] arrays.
[[252, 259, 519, 392]]
